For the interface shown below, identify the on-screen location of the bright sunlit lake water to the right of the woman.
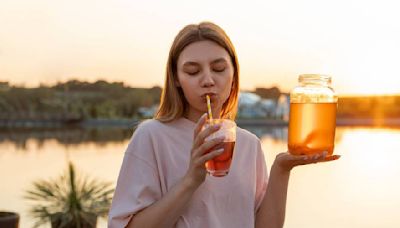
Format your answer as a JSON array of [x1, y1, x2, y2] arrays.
[[256, 128, 400, 228]]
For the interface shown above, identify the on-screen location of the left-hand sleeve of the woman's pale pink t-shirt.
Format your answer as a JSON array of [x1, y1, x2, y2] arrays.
[[108, 123, 161, 228]]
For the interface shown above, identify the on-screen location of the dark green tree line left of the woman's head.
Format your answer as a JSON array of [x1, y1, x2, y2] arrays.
[[0, 80, 161, 119]]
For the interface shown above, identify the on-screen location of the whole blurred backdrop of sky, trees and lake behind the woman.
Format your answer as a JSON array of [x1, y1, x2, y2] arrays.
[[0, 0, 400, 228]]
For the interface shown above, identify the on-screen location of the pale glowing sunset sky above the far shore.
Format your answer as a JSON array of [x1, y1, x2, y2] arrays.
[[0, 0, 400, 95]]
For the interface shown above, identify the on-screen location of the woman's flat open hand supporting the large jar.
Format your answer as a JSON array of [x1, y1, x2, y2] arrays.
[[274, 152, 340, 171]]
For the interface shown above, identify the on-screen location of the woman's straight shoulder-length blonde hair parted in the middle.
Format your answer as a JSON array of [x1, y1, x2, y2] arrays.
[[155, 22, 239, 122]]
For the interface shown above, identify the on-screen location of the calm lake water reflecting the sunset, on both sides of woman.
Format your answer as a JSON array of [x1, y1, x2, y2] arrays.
[[0, 128, 400, 228]]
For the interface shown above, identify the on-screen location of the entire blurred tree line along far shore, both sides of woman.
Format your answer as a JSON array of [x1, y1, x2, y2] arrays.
[[0, 80, 400, 120]]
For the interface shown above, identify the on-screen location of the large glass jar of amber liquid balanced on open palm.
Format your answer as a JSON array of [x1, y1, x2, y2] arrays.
[[288, 74, 338, 155]]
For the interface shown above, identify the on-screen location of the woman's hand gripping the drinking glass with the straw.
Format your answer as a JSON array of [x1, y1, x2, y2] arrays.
[[184, 113, 224, 188]]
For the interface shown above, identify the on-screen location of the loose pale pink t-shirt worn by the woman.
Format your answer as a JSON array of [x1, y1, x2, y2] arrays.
[[108, 118, 268, 228]]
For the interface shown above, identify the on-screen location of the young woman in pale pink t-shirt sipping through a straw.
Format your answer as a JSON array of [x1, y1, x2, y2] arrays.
[[109, 22, 339, 228]]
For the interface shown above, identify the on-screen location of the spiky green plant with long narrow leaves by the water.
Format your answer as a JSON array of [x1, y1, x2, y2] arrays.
[[25, 163, 114, 228]]
